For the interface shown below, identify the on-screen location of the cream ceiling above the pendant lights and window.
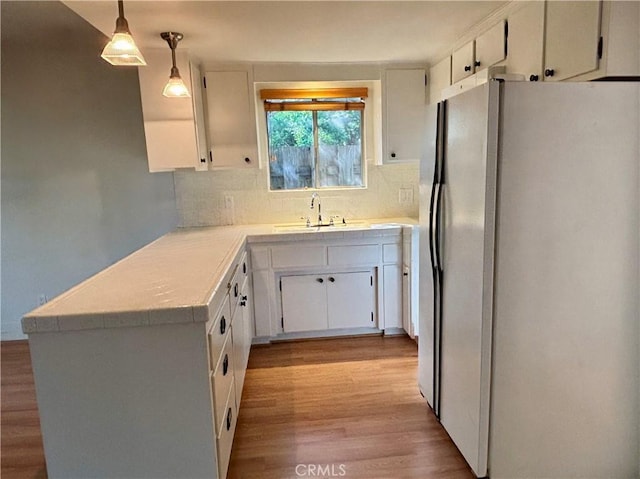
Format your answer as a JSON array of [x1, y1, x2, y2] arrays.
[[63, 0, 507, 63]]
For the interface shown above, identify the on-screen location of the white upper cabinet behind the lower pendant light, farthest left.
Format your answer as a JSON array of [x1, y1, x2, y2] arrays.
[[138, 48, 207, 172]]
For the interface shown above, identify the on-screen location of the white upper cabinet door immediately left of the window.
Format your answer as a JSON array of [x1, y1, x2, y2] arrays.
[[205, 71, 258, 168]]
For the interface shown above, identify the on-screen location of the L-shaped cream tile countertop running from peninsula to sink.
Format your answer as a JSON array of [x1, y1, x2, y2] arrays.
[[22, 218, 417, 334]]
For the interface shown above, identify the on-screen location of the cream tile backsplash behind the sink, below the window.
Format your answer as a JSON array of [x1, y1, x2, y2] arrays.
[[174, 163, 419, 227]]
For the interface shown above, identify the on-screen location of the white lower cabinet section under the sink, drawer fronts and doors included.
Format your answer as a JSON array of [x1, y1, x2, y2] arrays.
[[249, 226, 402, 342]]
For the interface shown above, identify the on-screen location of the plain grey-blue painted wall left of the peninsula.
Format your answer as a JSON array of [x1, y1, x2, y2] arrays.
[[1, 1, 177, 340]]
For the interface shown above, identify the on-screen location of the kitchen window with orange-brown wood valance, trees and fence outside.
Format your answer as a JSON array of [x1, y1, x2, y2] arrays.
[[260, 88, 367, 190]]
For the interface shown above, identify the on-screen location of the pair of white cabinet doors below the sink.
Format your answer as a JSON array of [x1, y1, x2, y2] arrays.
[[280, 271, 376, 333]]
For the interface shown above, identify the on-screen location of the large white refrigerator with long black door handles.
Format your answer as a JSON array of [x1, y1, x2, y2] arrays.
[[418, 81, 640, 479]]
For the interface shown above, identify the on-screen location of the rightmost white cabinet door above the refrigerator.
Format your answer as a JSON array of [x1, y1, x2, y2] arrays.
[[544, 1, 601, 81]]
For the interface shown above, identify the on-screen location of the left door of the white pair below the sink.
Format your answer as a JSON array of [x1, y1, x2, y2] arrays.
[[280, 274, 328, 333]]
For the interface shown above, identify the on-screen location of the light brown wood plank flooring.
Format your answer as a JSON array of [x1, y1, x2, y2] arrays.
[[1, 337, 474, 479]]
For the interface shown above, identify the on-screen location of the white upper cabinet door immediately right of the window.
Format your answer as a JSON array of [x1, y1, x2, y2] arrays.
[[385, 68, 426, 163]]
